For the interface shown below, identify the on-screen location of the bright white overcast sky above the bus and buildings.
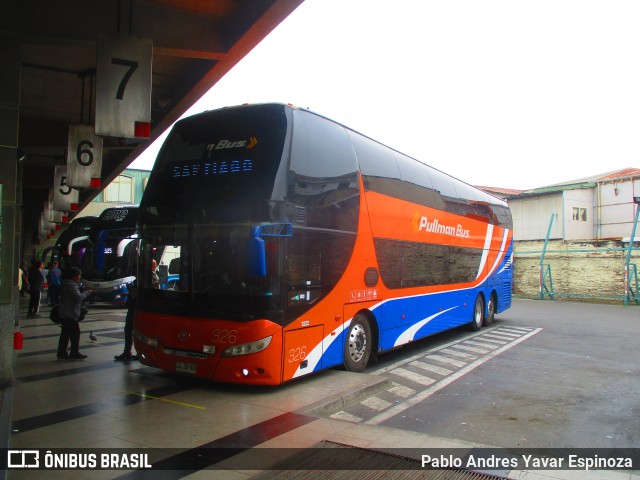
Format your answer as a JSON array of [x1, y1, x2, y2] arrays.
[[131, 0, 640, 189]]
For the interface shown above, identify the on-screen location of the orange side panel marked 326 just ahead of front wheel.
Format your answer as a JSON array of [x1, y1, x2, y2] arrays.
[[282, 325, 323, 381]]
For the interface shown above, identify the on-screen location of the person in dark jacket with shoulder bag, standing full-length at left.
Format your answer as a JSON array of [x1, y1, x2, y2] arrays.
[[58, 267, 91, 360]]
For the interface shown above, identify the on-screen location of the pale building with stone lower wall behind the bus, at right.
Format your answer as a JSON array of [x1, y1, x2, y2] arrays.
[[480, 168, 640, 304]]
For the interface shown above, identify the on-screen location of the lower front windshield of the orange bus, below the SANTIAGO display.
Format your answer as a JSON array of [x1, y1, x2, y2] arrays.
[[141, 224, 282, 323]]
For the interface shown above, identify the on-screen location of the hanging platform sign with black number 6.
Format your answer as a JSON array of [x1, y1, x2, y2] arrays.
[[66, 125, 102, 188]]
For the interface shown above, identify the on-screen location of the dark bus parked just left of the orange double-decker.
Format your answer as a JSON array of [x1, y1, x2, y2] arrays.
[[80, 205, 138, 306]]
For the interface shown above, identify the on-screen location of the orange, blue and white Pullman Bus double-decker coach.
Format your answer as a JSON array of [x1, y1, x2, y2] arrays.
[[134, 104, 512, 385]]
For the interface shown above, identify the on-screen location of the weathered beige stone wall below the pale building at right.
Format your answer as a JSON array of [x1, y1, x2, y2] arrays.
[[513, 240, 640, 302]]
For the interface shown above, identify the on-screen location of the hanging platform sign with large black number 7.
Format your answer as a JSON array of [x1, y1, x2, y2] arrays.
[[96, 34, 153, 138]]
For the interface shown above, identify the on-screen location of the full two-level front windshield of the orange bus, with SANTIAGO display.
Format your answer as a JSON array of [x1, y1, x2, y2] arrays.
[[138, 105, 287, 323]]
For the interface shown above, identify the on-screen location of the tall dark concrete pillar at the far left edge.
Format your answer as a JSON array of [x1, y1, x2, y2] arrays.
[[0, 35, 22, 388]]
